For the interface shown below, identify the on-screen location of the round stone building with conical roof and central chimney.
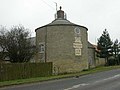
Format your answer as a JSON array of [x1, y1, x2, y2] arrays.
[[35, 7, 95, 73]]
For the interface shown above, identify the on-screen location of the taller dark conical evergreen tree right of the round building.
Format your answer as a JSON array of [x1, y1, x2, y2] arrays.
[[97, 29, 112, 65]]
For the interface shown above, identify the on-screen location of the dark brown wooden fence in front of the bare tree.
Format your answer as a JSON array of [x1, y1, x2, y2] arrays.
[[0, 62, 52, 81]]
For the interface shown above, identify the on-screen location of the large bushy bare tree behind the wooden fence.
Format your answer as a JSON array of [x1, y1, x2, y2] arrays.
[[0, 25, 35, 63]]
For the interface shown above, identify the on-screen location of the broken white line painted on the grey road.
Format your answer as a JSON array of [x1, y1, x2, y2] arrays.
[[64, 74, 120, 90]]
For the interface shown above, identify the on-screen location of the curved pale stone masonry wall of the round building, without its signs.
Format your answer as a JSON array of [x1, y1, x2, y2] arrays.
[[36, 25, 88, 73]]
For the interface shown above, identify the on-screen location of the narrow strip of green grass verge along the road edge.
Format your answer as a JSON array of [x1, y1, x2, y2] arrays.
[[0, 66, 120, 87]]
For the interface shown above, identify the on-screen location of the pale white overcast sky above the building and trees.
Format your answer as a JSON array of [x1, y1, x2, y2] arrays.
[[0, 0, 120, 44]]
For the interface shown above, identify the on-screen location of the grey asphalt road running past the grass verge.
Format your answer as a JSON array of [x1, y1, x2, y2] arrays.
[[0, 69, 120, 90]]
